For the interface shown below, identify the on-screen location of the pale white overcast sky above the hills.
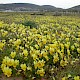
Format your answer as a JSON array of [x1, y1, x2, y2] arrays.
[[0, 0, 80, 8]]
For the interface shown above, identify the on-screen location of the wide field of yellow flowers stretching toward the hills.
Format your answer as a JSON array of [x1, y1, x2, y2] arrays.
[[0, 13, 80, 80]]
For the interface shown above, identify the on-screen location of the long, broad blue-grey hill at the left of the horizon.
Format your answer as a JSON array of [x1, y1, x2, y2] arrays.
[[0, 3, 39, 11]]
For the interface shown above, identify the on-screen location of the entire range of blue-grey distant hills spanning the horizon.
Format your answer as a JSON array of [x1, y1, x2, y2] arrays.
[[0, 3, 80, 12]]
